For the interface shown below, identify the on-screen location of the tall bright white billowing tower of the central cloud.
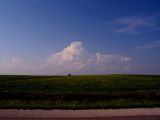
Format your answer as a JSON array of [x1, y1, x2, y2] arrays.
[[48, 41, 88, 69]]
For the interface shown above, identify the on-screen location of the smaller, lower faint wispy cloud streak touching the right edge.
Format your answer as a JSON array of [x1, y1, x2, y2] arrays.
[[136, 41, 160, 50]]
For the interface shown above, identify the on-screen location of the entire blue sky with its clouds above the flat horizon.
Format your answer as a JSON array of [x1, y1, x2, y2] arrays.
[[0, 0, 160, 75]]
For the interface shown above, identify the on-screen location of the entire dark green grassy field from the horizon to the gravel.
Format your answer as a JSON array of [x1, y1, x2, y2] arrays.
[[0, 75, 160, 109]]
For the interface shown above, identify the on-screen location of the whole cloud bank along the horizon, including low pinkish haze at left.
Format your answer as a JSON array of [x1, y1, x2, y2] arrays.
[[0, 41, 133, 75]]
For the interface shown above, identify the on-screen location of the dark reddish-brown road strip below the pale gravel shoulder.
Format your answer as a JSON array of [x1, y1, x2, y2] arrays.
[[0, 115, 160, 120]]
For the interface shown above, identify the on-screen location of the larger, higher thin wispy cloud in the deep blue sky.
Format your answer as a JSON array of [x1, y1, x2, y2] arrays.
[[113, 14, 160, 33]]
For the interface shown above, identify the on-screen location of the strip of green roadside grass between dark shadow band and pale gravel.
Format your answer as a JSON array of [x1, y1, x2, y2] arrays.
[[0, 99, 160, 109]]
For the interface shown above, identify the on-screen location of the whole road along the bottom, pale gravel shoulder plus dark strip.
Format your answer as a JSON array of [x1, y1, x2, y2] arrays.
[[0, 108, 160, 120]]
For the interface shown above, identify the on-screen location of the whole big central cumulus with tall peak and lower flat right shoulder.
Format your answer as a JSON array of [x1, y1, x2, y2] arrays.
[[45, 41, 132, 74]]
